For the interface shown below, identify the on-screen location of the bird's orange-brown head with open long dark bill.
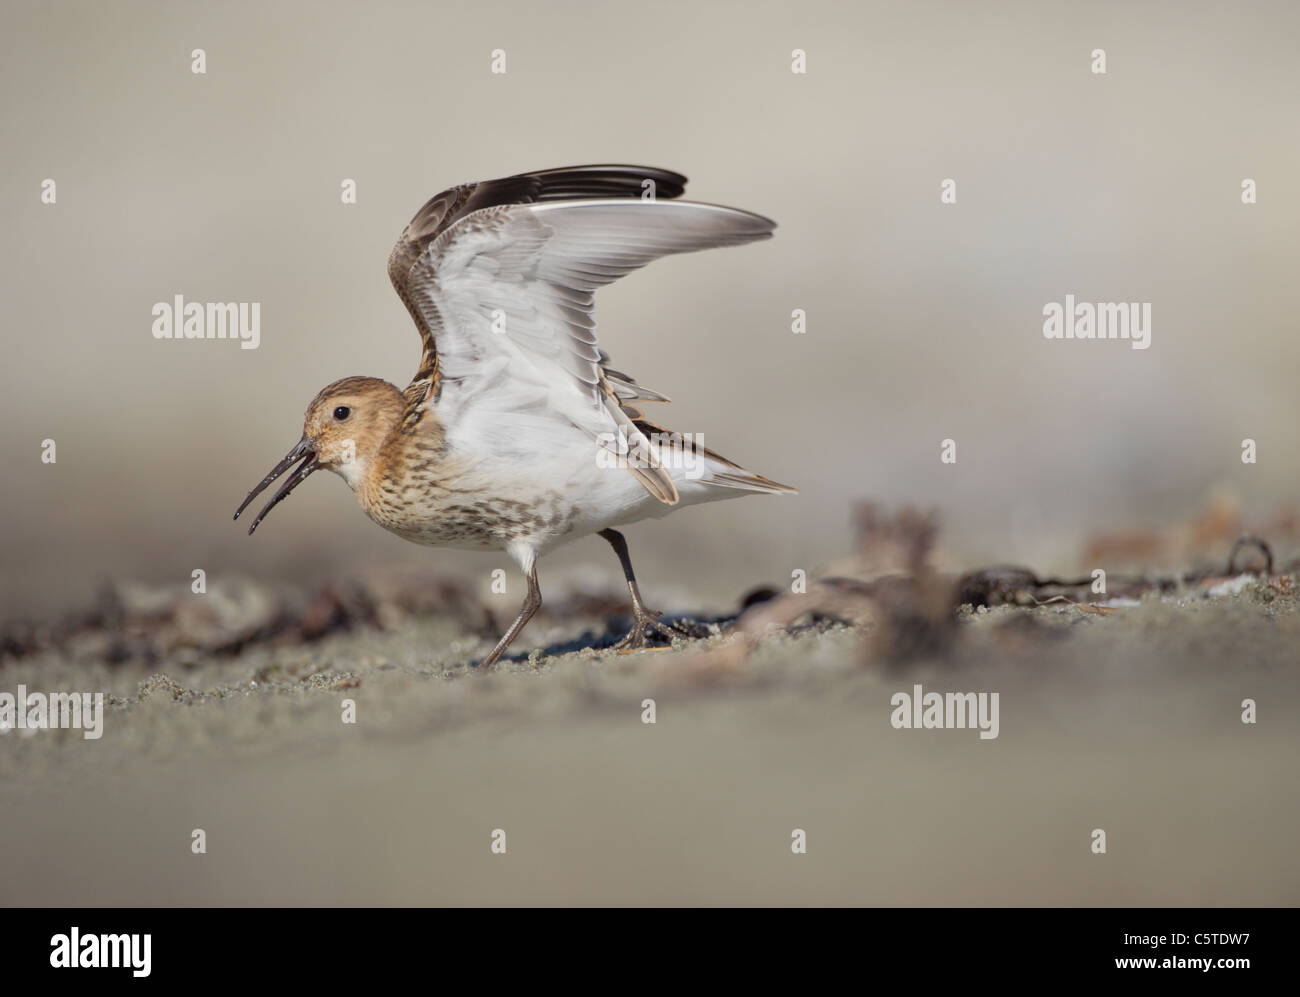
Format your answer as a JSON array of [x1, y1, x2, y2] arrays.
[[235, 377, 406, 533]]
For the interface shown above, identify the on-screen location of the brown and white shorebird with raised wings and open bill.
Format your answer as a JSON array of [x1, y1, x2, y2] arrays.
[[234, 164, 797, 668]]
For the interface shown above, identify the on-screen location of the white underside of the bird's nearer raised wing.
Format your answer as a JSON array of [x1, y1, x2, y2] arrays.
[[384, 168, 774, 503]]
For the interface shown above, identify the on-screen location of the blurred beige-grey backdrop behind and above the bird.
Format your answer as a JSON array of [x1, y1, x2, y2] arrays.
[[0, 0, 1300, 616]]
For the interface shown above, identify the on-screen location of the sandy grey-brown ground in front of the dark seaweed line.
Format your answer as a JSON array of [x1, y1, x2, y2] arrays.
[[0, 585, 1300, 905]]
